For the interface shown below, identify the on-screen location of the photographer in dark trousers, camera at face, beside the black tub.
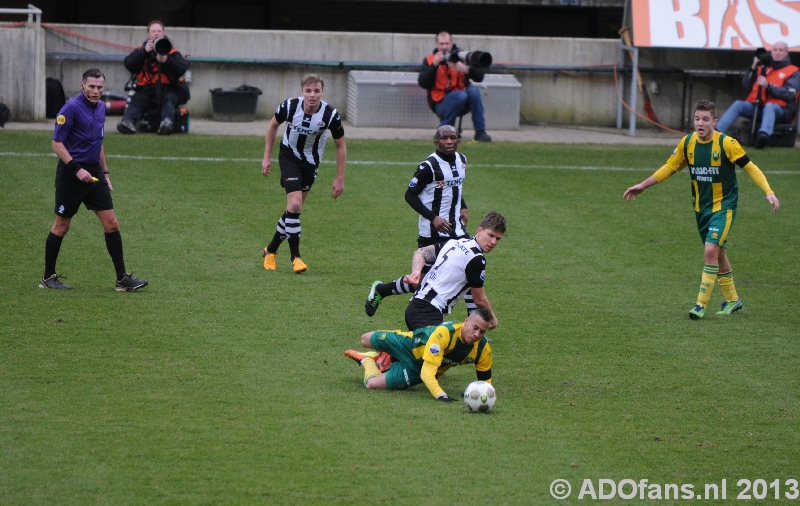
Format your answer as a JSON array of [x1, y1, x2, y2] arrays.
[[117, 20, 189, 135]]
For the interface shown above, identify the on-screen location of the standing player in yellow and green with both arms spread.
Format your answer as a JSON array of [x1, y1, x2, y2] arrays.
[[622, 100, 780, 320]]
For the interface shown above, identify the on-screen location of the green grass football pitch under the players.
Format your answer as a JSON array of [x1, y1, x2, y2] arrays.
[[0, 131, 800, 505]]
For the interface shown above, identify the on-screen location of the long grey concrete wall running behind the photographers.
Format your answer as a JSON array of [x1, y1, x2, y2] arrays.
[[46, 25, 764, 127]]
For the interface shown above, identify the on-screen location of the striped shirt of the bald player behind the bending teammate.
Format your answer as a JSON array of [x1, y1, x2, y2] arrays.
[[406, 151, 467, 241]]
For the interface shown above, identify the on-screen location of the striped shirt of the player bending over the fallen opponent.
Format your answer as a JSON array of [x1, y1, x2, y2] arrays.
[[414, 237, 486, 315]]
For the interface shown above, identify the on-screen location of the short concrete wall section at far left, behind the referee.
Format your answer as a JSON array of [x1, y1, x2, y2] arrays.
[[0, 24, 47, 121]]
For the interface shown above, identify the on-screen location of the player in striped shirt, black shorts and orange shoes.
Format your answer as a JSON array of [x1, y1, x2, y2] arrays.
[[261, 74, 347, 274]]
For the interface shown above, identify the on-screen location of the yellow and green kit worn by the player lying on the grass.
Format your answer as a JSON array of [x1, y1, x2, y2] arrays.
[[370, 322, 492, 397]]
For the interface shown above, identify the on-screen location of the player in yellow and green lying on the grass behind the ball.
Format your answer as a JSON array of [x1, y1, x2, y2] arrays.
[[344, 308, 492, 402]]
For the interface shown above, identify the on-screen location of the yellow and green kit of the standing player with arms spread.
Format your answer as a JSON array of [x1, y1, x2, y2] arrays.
[[653, 131, 773, 307]]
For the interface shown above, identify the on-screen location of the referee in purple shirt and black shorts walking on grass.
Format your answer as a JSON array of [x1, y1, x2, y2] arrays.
[[39, 69, 147, 292]]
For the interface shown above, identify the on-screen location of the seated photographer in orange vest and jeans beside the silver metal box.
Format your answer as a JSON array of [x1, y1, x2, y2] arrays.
[[417, 32, 492, 142]]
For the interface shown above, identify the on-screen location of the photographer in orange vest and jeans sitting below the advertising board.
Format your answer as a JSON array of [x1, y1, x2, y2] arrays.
[[716, 42, 800, 149]]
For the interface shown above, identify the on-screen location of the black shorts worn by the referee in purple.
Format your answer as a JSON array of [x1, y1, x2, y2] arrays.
[[55, 160, 114, 218]]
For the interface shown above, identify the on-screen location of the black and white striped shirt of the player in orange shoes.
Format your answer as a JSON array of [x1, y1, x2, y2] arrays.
[[275, 97, 344, 166]]
